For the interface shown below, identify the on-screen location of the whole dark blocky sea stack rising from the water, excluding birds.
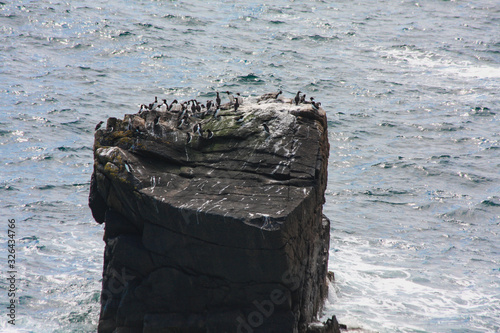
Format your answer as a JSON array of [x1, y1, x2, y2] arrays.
[[89, 94, 330, 332]]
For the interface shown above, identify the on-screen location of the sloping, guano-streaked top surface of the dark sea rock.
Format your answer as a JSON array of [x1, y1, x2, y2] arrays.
[[94, 93, 328, 230]]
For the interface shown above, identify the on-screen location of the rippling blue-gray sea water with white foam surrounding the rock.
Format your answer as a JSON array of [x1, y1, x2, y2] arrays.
[[0, 0, 500, 332]]
